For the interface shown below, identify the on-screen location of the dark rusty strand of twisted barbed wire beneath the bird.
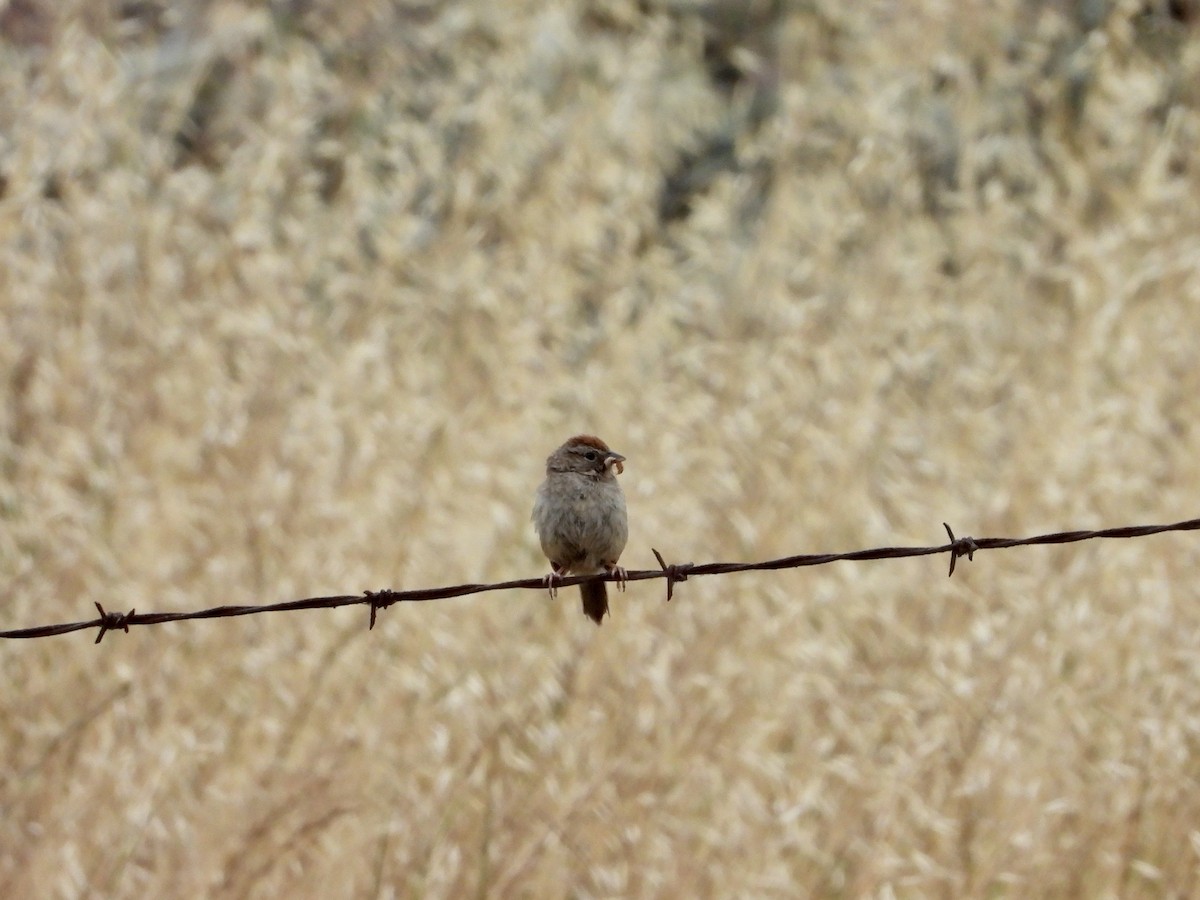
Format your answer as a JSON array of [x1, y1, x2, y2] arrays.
[[0, 518, 1200, 643]]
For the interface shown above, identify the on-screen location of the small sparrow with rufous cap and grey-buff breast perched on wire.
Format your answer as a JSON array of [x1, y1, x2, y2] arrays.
[[533, 434, 629, 625]]
